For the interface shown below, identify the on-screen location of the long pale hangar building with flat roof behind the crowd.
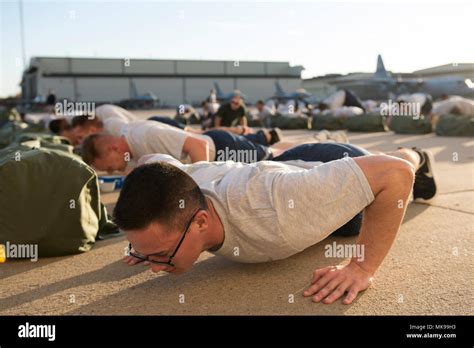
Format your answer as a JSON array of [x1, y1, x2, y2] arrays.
[[21, 57, 304, 106]]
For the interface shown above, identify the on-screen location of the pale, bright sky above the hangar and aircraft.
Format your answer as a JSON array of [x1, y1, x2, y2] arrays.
[[0, 0, 474, 96]]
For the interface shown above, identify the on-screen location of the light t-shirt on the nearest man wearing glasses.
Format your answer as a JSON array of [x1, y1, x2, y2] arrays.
[[140, 156, 374, 263]]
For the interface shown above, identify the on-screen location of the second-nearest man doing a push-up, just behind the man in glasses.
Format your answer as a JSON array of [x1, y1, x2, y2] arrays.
[[81, 121, 278, 172]]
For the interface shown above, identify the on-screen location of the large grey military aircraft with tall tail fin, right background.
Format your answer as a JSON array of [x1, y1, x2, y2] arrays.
[[330, 54, 474, 100]]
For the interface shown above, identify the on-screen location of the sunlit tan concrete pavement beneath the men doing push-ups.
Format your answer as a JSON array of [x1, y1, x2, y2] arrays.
[[0, 131, 474, 315]]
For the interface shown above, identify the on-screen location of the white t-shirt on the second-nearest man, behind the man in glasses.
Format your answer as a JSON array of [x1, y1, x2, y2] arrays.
[[120, 121, 216, 163]]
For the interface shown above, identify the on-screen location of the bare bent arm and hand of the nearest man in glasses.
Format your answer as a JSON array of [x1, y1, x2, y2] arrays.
[[304, 156, 414, 304]]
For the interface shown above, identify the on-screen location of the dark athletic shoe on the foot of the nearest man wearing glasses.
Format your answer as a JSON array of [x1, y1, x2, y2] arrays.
[[412, 147, 437, 201]]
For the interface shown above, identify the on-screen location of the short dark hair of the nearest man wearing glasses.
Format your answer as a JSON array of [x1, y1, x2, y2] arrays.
[[113, 162, 207, 230]]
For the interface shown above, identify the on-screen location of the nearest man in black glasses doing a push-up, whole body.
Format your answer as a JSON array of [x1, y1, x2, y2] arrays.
[[114, 143, 436, 304]]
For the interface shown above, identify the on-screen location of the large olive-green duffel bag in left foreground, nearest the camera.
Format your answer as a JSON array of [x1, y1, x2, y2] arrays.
[[0, 144, 117, 257]]
